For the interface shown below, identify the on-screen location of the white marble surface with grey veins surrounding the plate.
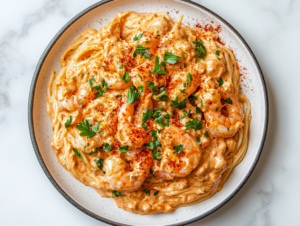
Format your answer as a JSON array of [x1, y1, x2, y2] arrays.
[[0, 0, 300, 226]]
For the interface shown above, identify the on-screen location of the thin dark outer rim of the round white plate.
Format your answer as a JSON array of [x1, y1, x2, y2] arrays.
[[27, 0, 269, 226]]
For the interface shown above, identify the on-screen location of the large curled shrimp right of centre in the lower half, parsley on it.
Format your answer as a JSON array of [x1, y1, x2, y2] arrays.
[[154, 126, 201, 180]]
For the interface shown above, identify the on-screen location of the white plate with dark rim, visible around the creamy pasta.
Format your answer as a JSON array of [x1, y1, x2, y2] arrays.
[[28, 0, 268, 226]]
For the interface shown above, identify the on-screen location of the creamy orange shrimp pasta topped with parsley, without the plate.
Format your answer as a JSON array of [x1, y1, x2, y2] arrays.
[[47, 12, 251, 214]]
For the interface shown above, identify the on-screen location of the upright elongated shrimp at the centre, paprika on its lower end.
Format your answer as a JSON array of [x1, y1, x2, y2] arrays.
[[117, 89, 151, 148]]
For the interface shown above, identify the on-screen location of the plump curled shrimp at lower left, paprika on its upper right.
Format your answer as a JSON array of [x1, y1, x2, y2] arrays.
[[103, 149, 152, 191]]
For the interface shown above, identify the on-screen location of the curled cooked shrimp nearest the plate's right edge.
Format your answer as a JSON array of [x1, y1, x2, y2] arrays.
[[204, 94, 244, 138]]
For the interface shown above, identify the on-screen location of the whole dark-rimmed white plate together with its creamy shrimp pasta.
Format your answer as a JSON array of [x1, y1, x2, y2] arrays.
[[28, 0, 268, 225]]
